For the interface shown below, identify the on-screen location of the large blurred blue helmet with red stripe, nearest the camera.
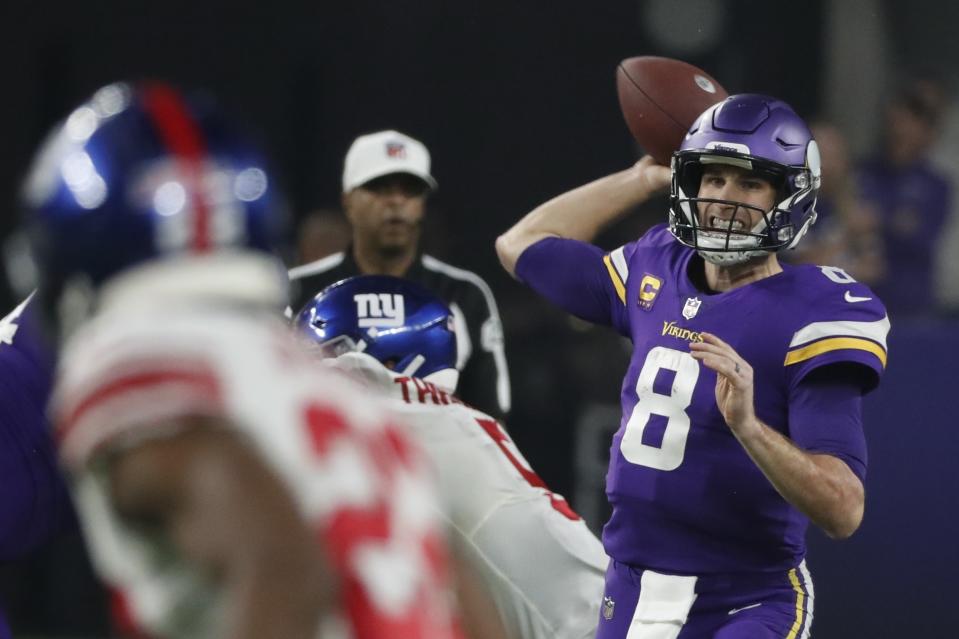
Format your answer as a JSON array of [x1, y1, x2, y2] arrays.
[[23, 84, 285, 336]]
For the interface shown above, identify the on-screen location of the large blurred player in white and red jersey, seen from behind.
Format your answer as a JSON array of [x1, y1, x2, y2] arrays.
[[25, 84, 468, 639]]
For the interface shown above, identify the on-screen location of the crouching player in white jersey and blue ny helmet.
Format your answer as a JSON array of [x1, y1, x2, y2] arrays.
[[295, 275, 607, 639]]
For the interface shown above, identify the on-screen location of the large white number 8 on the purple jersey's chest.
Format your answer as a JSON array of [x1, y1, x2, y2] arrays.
[[620, 346, 699, 470]]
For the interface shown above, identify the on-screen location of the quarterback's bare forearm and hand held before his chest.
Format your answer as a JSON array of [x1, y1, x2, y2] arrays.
[[690, 333, 865, 539]]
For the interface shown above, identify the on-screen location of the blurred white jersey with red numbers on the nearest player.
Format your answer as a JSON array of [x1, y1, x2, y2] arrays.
[[52, 308, 455, 639]]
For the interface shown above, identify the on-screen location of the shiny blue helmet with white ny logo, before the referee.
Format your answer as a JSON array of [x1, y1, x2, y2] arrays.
[[294, 275, 459, 390]]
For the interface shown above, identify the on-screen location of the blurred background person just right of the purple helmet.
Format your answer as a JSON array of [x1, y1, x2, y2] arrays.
[[786, 120, 883, 284]]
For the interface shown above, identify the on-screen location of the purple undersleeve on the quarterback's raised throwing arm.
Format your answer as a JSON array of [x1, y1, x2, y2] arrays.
[[516, 237, 628, 335]]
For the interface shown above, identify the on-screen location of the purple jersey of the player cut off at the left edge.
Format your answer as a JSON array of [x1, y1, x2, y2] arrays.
[[0, 301, 69, 560]]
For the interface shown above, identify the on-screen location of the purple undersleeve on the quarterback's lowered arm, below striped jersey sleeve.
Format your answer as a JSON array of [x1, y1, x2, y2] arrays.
[[789, 366, 866, 482]]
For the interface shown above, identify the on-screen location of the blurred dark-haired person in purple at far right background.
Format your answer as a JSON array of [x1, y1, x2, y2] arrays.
[[859, 79, 953, 318]]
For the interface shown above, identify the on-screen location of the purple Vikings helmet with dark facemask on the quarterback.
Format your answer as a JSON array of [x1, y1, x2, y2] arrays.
[[669, 94, 821, 264]]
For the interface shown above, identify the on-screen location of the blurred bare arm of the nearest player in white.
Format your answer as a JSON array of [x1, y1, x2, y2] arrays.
[[110, 418, 332, 639]]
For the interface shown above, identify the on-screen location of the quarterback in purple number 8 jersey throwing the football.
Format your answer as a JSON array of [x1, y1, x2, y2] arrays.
[[497, 94, 889, 639]]
